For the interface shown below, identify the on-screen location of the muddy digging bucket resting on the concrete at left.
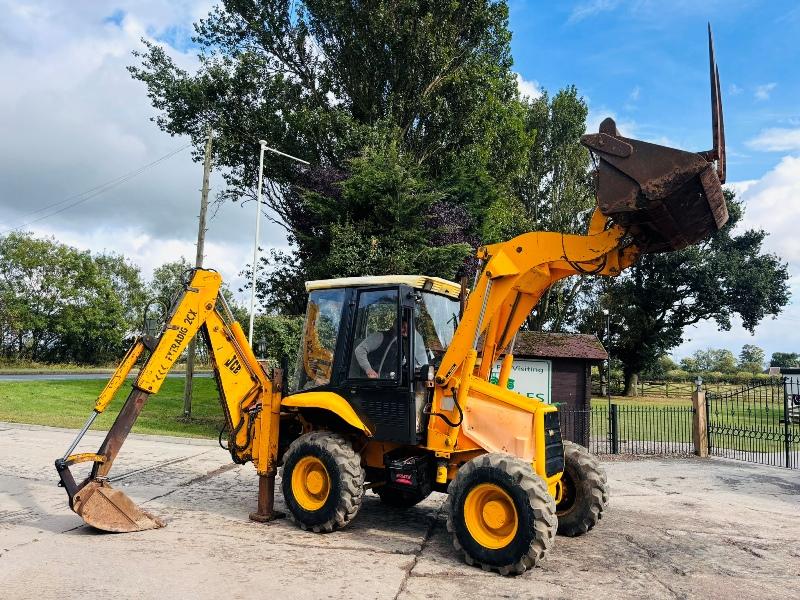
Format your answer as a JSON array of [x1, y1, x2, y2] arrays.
[[72, 481, 164, 533]]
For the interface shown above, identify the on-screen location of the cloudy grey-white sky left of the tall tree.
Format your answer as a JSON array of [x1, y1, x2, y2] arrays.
[[0, 0, 286, 300]]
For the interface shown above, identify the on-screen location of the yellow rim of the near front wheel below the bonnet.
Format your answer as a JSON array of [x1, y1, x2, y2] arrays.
[[464, 483, 519, 550]]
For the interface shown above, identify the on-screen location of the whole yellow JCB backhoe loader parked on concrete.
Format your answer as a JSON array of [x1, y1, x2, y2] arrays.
[[56, 30, 727, 574]]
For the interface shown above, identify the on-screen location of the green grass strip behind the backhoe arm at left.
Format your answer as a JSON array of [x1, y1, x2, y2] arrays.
[[0, 377, 224, 438]]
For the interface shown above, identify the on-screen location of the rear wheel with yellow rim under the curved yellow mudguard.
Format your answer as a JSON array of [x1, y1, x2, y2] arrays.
[[281, 432, 364, 532]]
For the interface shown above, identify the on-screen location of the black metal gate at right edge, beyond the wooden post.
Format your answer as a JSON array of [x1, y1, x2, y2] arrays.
[[706, 377, 800, 469]]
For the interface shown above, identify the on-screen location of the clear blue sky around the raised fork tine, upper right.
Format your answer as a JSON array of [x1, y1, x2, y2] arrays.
[[511, 0, 800, 181]]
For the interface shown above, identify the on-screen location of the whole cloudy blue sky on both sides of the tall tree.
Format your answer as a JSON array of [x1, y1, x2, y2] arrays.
[[0, 0, 800, 358]]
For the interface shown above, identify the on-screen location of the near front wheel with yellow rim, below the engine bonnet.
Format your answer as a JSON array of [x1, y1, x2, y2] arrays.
[[447, 453, 558, 575]]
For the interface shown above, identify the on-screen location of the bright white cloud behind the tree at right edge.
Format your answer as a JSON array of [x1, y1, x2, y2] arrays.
[[673, 156, 800, 357]]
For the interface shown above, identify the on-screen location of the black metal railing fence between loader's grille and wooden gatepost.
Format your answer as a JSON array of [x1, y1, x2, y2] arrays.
[[559, 404, 694, 454]]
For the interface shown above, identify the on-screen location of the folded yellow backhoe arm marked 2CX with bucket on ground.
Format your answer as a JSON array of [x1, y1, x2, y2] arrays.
[[56, 269, 280, 531]]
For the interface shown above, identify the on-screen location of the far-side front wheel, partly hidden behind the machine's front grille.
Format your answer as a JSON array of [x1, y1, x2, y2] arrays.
[[556, 441, 608, 537]]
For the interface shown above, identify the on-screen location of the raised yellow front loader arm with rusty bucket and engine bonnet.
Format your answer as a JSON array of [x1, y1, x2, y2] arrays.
[[427, 27, 728, 478]]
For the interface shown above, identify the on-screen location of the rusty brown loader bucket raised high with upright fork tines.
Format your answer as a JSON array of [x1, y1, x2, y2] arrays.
[[581, 26, 728, 253]]
